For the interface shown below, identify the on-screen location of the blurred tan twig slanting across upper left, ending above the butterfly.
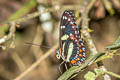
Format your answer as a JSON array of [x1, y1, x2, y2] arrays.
[[0, 5, 85, 27]]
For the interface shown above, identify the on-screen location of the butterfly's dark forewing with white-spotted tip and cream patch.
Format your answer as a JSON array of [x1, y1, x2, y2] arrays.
[[59, 10, 76, 60]]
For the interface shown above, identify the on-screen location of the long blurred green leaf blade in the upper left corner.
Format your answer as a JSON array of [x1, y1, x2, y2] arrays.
[[0, 0, 37, 37]]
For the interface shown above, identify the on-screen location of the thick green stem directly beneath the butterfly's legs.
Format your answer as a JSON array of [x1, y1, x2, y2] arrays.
[[57, 54, 101, 80]]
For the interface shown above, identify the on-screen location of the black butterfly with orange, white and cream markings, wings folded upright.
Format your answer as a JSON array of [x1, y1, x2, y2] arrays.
[[56, 10, 85, 66]]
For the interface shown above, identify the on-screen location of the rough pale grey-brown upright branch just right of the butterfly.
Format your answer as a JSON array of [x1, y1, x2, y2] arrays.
[[82, 0, 111, 80]]
